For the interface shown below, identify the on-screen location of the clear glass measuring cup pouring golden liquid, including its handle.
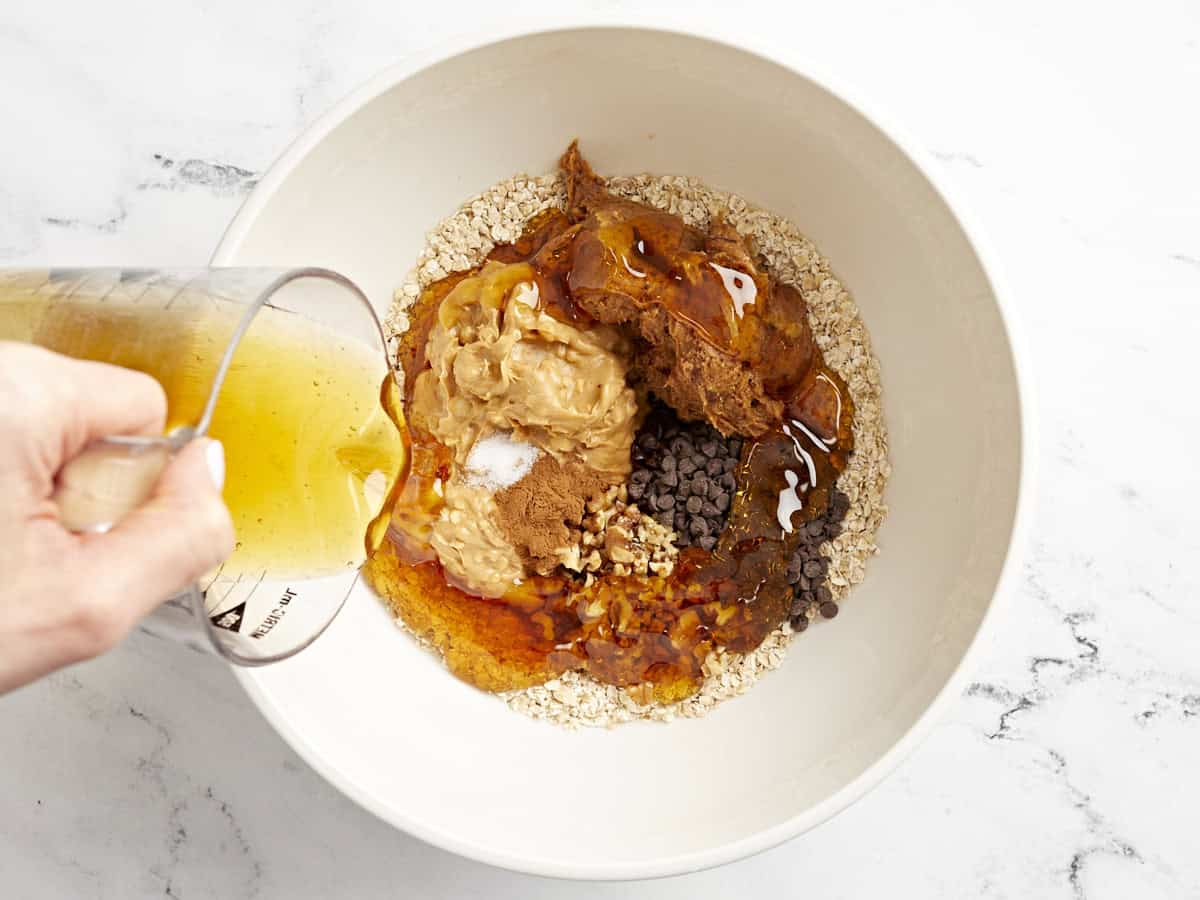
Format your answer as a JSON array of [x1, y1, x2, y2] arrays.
[[0, 269, 404, 665]]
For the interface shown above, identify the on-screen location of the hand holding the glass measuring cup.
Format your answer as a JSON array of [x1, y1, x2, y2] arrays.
[[0, 341, 233, 694]]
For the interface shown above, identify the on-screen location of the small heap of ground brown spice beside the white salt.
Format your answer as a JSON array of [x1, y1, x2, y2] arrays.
[[496, 454, 610, 575]]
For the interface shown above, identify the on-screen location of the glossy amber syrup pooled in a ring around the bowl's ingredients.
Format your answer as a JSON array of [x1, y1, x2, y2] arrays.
[[366, 210, 853, 702]]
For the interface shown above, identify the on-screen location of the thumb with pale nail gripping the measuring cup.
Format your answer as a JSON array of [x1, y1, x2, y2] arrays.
[[85, 438, 234, 624]]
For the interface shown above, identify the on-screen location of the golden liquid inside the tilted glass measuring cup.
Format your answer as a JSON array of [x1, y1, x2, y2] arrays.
[[0, 274, 406, 577]]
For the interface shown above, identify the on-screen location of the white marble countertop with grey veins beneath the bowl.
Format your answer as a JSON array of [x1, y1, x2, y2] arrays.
[[0, 0, 1200, 900]]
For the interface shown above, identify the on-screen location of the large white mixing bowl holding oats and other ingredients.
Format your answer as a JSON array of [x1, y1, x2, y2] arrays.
[[208, 21, 1031, 878]]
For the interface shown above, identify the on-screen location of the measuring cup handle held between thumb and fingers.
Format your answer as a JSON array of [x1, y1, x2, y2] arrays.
[[53, 437, 174, 533]]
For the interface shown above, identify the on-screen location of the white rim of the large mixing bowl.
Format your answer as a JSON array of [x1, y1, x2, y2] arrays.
[[211, 13, 1037, 881]]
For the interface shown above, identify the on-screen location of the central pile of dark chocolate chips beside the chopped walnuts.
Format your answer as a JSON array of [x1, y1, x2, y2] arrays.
[[628, 404, 742, 550]]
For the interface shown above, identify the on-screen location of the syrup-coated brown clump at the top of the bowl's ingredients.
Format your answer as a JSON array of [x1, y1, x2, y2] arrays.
[[549, 144, 828, 437]]
